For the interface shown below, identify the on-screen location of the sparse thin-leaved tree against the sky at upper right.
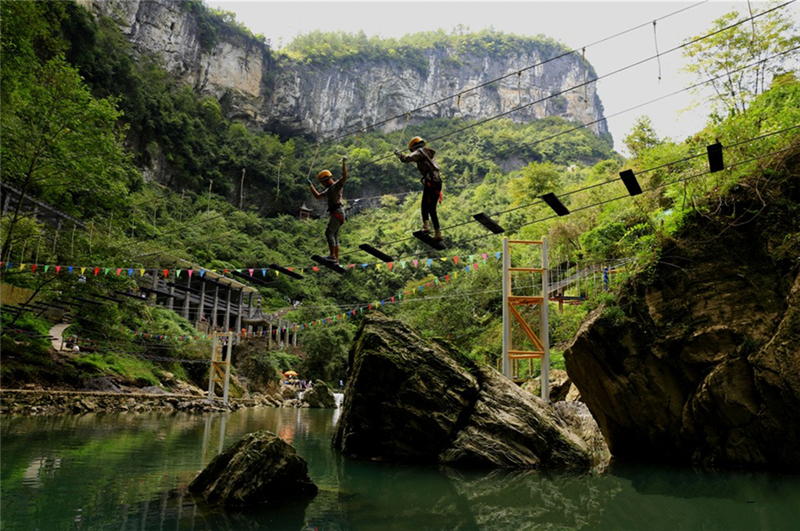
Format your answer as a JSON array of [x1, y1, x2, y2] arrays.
[[683, 3, 800, 116]]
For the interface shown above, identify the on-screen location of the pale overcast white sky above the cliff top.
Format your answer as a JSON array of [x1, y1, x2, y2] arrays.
[[206, 0, 800, 153]]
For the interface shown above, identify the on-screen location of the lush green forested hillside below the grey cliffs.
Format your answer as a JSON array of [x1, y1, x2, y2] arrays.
[[0, 2, 800, 390]]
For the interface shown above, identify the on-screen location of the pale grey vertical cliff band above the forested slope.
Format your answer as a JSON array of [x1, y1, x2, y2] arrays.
[[78, 0, 608, 138]]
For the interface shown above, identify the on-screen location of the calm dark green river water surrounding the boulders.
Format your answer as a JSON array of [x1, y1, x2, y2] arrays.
[[0, 408, 800, 531]]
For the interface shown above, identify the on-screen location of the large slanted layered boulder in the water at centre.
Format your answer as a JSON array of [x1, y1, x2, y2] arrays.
[[333, 314, 599, 468]]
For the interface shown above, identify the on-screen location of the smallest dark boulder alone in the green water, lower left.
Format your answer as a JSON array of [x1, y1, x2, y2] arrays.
[[189, 431, 317, 506]]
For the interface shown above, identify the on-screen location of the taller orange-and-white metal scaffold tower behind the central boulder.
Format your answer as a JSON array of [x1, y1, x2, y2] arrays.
[[503, 238, 550, 401]]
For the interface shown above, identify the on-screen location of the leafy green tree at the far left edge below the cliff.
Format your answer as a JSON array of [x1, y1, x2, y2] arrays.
[[0, 57, 137, 261]]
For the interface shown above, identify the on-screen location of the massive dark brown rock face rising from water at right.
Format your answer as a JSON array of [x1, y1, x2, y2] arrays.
[[565, 153, 800, 469]]
